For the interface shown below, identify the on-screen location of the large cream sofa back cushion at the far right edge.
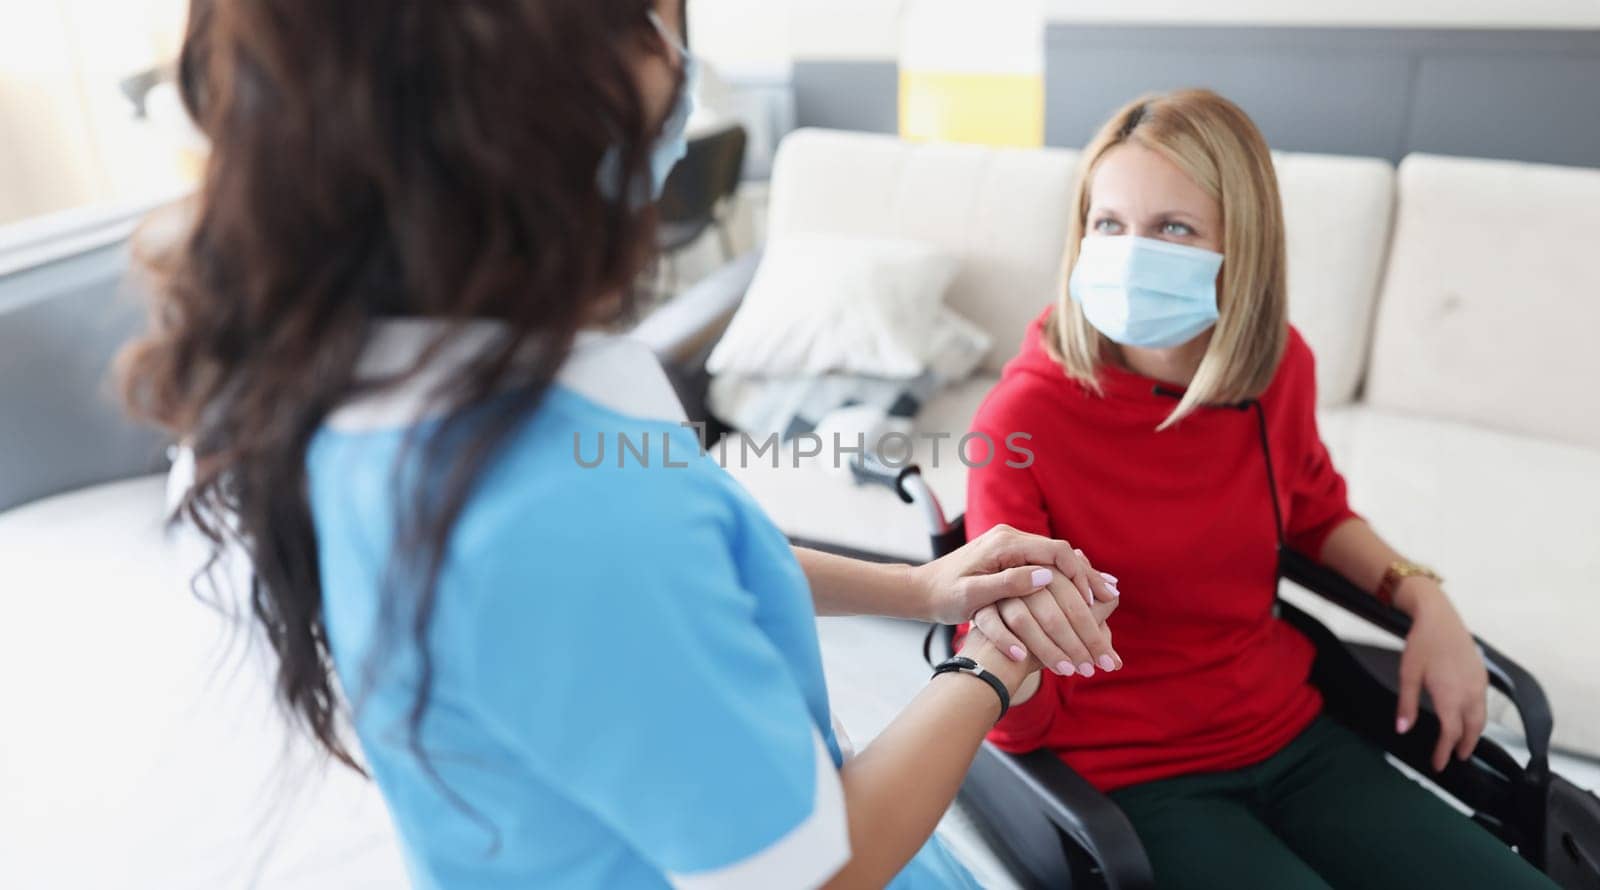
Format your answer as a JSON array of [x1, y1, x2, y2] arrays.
[[1368, 155, 1600, 451]]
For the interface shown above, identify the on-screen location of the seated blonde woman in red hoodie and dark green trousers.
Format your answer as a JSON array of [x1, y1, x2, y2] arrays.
[[966, 91, 1549, 888]]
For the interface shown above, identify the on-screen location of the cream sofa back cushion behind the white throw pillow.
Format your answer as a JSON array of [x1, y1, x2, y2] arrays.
[[768, 130, 1077, 371]]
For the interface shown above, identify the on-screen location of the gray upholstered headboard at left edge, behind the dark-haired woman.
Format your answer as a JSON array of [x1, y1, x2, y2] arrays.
[[0, 201, 166, 511]]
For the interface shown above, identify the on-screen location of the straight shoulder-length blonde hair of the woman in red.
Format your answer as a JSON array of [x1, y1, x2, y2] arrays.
[[1045, 90, 1288, 429]]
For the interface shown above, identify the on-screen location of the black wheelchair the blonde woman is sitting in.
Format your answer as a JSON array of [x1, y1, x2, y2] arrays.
[[851, 459, 1600, 890]]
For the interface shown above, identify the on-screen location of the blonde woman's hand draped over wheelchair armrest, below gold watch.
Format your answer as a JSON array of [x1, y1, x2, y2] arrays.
[[1395, 578, 1488, 772]]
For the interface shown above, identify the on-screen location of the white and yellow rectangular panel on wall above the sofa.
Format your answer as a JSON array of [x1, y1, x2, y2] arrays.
[[899, 0, 1045, 147]]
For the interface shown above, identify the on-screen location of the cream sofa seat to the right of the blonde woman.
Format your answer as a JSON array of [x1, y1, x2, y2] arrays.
[[1315, 408, 1600, 752]]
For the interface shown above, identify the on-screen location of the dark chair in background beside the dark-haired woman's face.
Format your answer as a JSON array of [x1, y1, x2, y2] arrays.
[[658, 123, 749, 293]]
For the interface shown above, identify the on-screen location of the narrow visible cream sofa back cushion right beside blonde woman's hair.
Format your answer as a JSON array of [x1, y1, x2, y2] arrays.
[[1272, 152, 1395, 405]]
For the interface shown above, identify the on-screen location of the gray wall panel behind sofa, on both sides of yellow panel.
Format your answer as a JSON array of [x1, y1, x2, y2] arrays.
[[794, 24, 1600, 166]]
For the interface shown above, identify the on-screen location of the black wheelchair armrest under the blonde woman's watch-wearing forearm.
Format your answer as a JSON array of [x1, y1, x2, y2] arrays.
[[1278, 549, 1554, 781]]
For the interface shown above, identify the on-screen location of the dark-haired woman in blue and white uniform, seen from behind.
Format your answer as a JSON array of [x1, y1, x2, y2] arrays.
[[126, 0, 1120, 888]]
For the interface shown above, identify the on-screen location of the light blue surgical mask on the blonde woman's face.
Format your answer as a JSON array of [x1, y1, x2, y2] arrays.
[[1067, 235, 1222, 349]]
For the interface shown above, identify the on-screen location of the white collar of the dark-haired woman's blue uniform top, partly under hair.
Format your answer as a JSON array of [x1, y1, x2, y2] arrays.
[[328, 319, 686, 432]]
